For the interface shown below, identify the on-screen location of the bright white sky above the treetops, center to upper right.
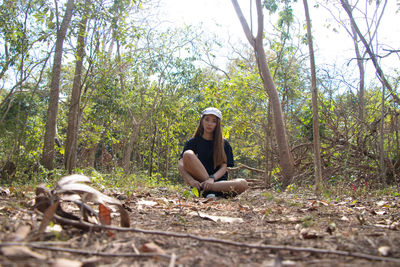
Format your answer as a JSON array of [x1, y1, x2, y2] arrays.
[[161, 0, 400, 80]]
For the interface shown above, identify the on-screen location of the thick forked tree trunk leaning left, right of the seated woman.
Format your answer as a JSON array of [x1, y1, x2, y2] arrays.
[[232, 0, 294, 188]]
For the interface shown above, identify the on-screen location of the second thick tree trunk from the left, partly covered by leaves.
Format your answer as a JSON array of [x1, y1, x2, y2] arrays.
[[64, 0, 89, 173]]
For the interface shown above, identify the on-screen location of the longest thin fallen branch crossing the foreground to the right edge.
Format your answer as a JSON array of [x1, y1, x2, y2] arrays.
[[34, 215, 400, 263]]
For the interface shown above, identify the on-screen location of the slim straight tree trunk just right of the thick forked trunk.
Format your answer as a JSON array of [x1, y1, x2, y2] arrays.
[[303, 0, 322, 192]]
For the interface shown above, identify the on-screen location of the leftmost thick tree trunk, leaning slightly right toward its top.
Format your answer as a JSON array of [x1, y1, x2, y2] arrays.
[[42, 0, 74, 170]]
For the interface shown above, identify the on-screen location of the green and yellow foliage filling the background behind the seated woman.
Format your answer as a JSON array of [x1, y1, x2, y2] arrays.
[[0, 0, 400, 195]]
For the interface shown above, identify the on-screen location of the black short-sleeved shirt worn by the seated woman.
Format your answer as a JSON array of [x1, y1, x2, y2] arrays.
[[180, 136, 235, 178]]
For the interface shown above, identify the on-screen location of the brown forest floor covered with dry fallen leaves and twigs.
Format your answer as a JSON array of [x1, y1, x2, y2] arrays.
[[0, 180, 400, 267]]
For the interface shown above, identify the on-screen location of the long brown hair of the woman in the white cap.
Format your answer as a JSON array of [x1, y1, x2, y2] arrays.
[[193, 116, 227, 168]]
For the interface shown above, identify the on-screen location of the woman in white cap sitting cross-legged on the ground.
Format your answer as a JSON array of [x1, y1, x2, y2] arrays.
[[178, 108, 248, 197]]
